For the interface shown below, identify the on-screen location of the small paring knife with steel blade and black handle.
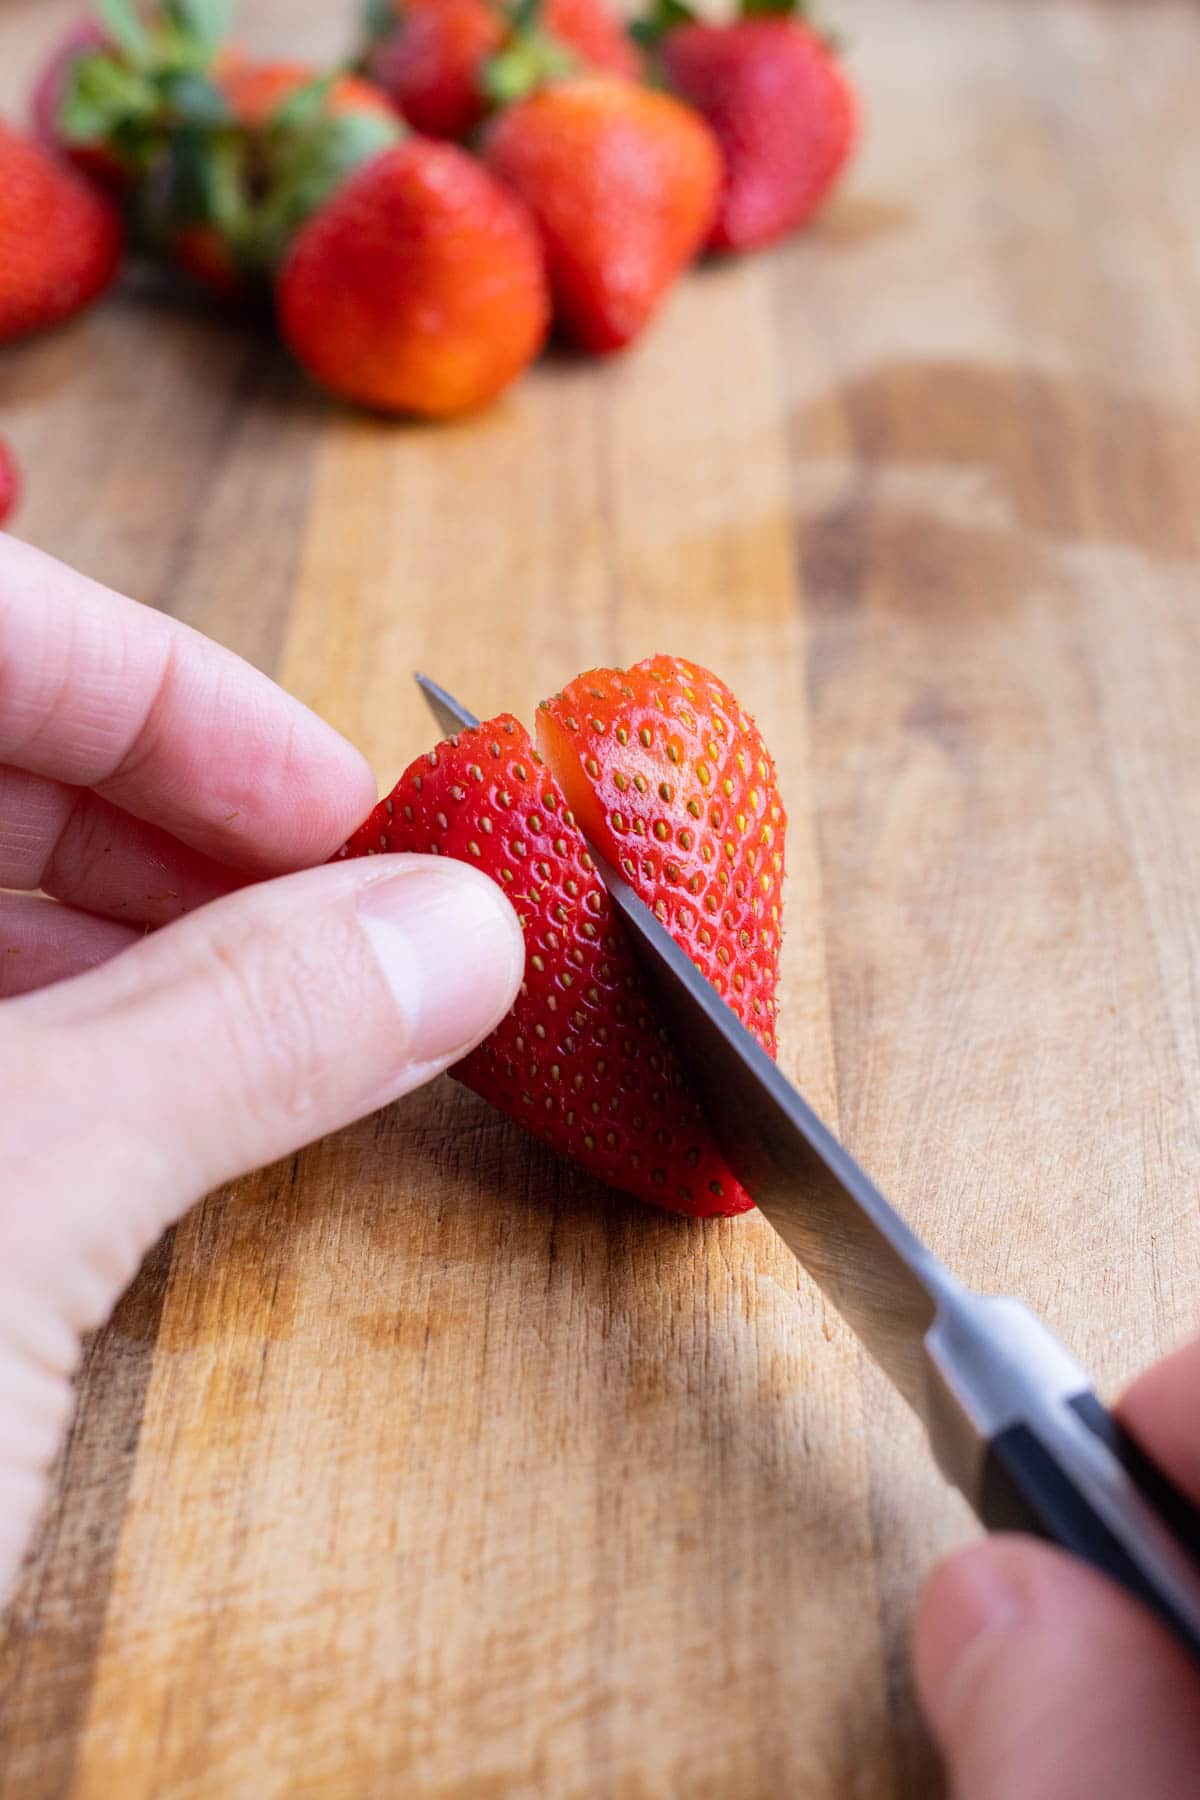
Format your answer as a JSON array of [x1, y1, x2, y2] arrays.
[[417, 675, 1200, 1660]]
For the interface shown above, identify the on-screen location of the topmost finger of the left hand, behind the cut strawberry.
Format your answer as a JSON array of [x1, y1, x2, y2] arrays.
[[0, 536, 376, 873]]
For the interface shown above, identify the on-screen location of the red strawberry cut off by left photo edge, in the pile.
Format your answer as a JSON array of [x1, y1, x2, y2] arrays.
[[0, 124, 121, 344]]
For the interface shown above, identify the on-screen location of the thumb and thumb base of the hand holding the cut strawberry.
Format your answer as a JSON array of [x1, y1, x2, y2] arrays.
[[0, 857, 524, 1602]]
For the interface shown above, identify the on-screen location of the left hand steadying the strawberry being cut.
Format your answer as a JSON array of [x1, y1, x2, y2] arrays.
[[0, 536, 524, 1598]]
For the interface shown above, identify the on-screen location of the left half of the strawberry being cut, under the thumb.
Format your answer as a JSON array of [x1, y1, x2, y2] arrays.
[[332, 715, 752, 1217]]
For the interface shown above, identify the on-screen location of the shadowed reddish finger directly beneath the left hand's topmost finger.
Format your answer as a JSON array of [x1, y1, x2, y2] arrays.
[[0, 769, 250, 925]]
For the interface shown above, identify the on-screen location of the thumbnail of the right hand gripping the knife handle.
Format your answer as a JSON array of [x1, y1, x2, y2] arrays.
[[916, 1544, 1020, 1737]]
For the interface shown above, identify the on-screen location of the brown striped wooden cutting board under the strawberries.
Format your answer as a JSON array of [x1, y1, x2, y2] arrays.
[[0, 0, 1200, 1800]]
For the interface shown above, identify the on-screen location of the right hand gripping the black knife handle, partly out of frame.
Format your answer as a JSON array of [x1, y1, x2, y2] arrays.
[[916, 1341, 1200, 1800]]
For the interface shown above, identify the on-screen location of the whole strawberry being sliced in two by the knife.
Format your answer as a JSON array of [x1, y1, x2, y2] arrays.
[[340, 657, 784, 1217]]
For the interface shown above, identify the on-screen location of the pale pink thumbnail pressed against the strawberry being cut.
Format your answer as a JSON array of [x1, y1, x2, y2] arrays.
[[358, 862, 524, 1064]]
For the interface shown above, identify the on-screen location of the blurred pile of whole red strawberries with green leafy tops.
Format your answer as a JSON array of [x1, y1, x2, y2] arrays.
[[0, 0, 856, 471]]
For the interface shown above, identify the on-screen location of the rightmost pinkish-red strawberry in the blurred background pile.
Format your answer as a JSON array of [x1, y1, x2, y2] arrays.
[[658, 16, 858, 250]]
